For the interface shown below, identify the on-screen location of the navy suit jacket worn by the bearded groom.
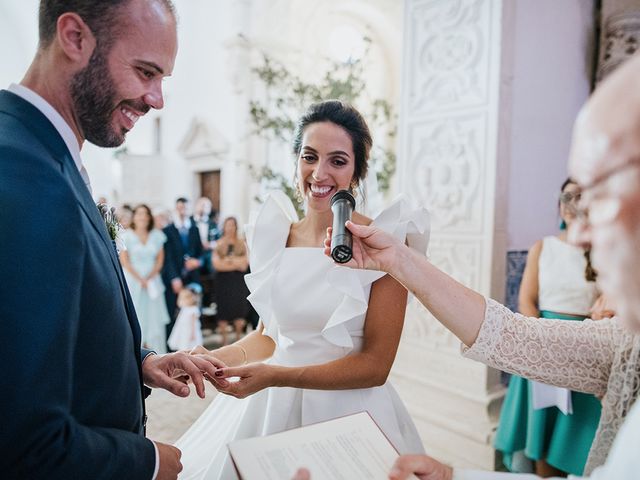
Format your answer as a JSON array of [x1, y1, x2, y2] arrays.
[[0, 90, 155, 480]]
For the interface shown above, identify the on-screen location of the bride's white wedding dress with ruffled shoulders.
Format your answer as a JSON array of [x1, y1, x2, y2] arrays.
[[176, 192, 429, 480]]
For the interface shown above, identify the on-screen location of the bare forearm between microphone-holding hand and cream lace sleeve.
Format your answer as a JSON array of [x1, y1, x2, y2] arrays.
[[390, 248, 485, 346]]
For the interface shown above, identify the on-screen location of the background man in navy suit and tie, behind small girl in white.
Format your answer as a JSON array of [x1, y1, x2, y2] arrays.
[[161, 197, 204, 344]]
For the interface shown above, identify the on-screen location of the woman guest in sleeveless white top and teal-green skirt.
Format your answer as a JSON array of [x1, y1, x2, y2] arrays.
[[494, 179, 600, 477]]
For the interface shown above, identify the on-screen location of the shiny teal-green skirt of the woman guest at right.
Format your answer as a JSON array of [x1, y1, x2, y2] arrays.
[[494, 311, 601, 475]]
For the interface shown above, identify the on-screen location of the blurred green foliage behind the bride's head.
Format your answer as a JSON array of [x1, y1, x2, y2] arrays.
[[249, 38, 396, 207]]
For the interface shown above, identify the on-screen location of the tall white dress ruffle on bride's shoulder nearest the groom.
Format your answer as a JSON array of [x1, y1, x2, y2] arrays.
[[244, 191, 298, 340]]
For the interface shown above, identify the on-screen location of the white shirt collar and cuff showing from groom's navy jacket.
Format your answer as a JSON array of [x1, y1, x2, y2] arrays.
[[8, 83, 160, 480]]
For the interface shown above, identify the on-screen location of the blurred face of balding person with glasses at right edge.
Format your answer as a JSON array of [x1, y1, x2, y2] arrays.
[[569, 56, 640, 331]]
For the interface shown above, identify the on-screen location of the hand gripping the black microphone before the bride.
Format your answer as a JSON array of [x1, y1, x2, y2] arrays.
[[324, 221, 404, 272]]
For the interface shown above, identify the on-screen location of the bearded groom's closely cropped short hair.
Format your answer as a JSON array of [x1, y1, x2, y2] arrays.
[[38, 0, 176, 49]]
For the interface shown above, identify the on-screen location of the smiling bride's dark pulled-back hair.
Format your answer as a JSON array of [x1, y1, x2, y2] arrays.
[[293, 100, 373, 186]]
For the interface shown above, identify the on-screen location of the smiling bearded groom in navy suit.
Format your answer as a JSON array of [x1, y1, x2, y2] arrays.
[[0, 0, 222, 480]]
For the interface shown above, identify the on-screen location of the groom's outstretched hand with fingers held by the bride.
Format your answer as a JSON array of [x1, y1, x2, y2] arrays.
[[142, 352, 226, 398]]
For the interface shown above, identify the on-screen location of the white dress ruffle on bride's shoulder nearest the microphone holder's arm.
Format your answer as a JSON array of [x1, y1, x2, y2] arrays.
[[322, 195, 430, 349]]
